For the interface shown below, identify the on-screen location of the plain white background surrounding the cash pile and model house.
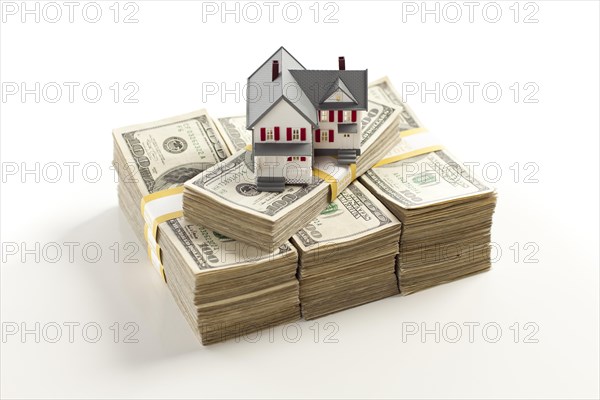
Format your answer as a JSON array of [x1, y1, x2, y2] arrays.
[[0, 1, 600, 398]]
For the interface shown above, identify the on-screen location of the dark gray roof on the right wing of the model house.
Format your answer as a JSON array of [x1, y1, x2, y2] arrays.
[[290, 69, 368, 110]]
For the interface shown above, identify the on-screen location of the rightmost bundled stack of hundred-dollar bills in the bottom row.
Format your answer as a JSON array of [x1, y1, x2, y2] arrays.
[[360, 150, 496, 294]]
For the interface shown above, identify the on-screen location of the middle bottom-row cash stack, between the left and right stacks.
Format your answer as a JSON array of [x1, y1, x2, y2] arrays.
[[292, 182, 400, 319]]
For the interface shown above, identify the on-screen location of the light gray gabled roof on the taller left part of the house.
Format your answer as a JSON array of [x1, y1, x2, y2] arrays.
[[246, 47, 317, 129]]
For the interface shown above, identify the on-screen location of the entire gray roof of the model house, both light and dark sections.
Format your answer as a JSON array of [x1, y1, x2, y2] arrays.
[[246, 47, 368, 129]]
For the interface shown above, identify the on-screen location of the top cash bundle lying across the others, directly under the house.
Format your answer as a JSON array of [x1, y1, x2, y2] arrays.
[[183, 101, 401, 250]]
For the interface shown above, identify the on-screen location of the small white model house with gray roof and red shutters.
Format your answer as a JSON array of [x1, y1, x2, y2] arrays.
[[246, 47, 368, 192]]
